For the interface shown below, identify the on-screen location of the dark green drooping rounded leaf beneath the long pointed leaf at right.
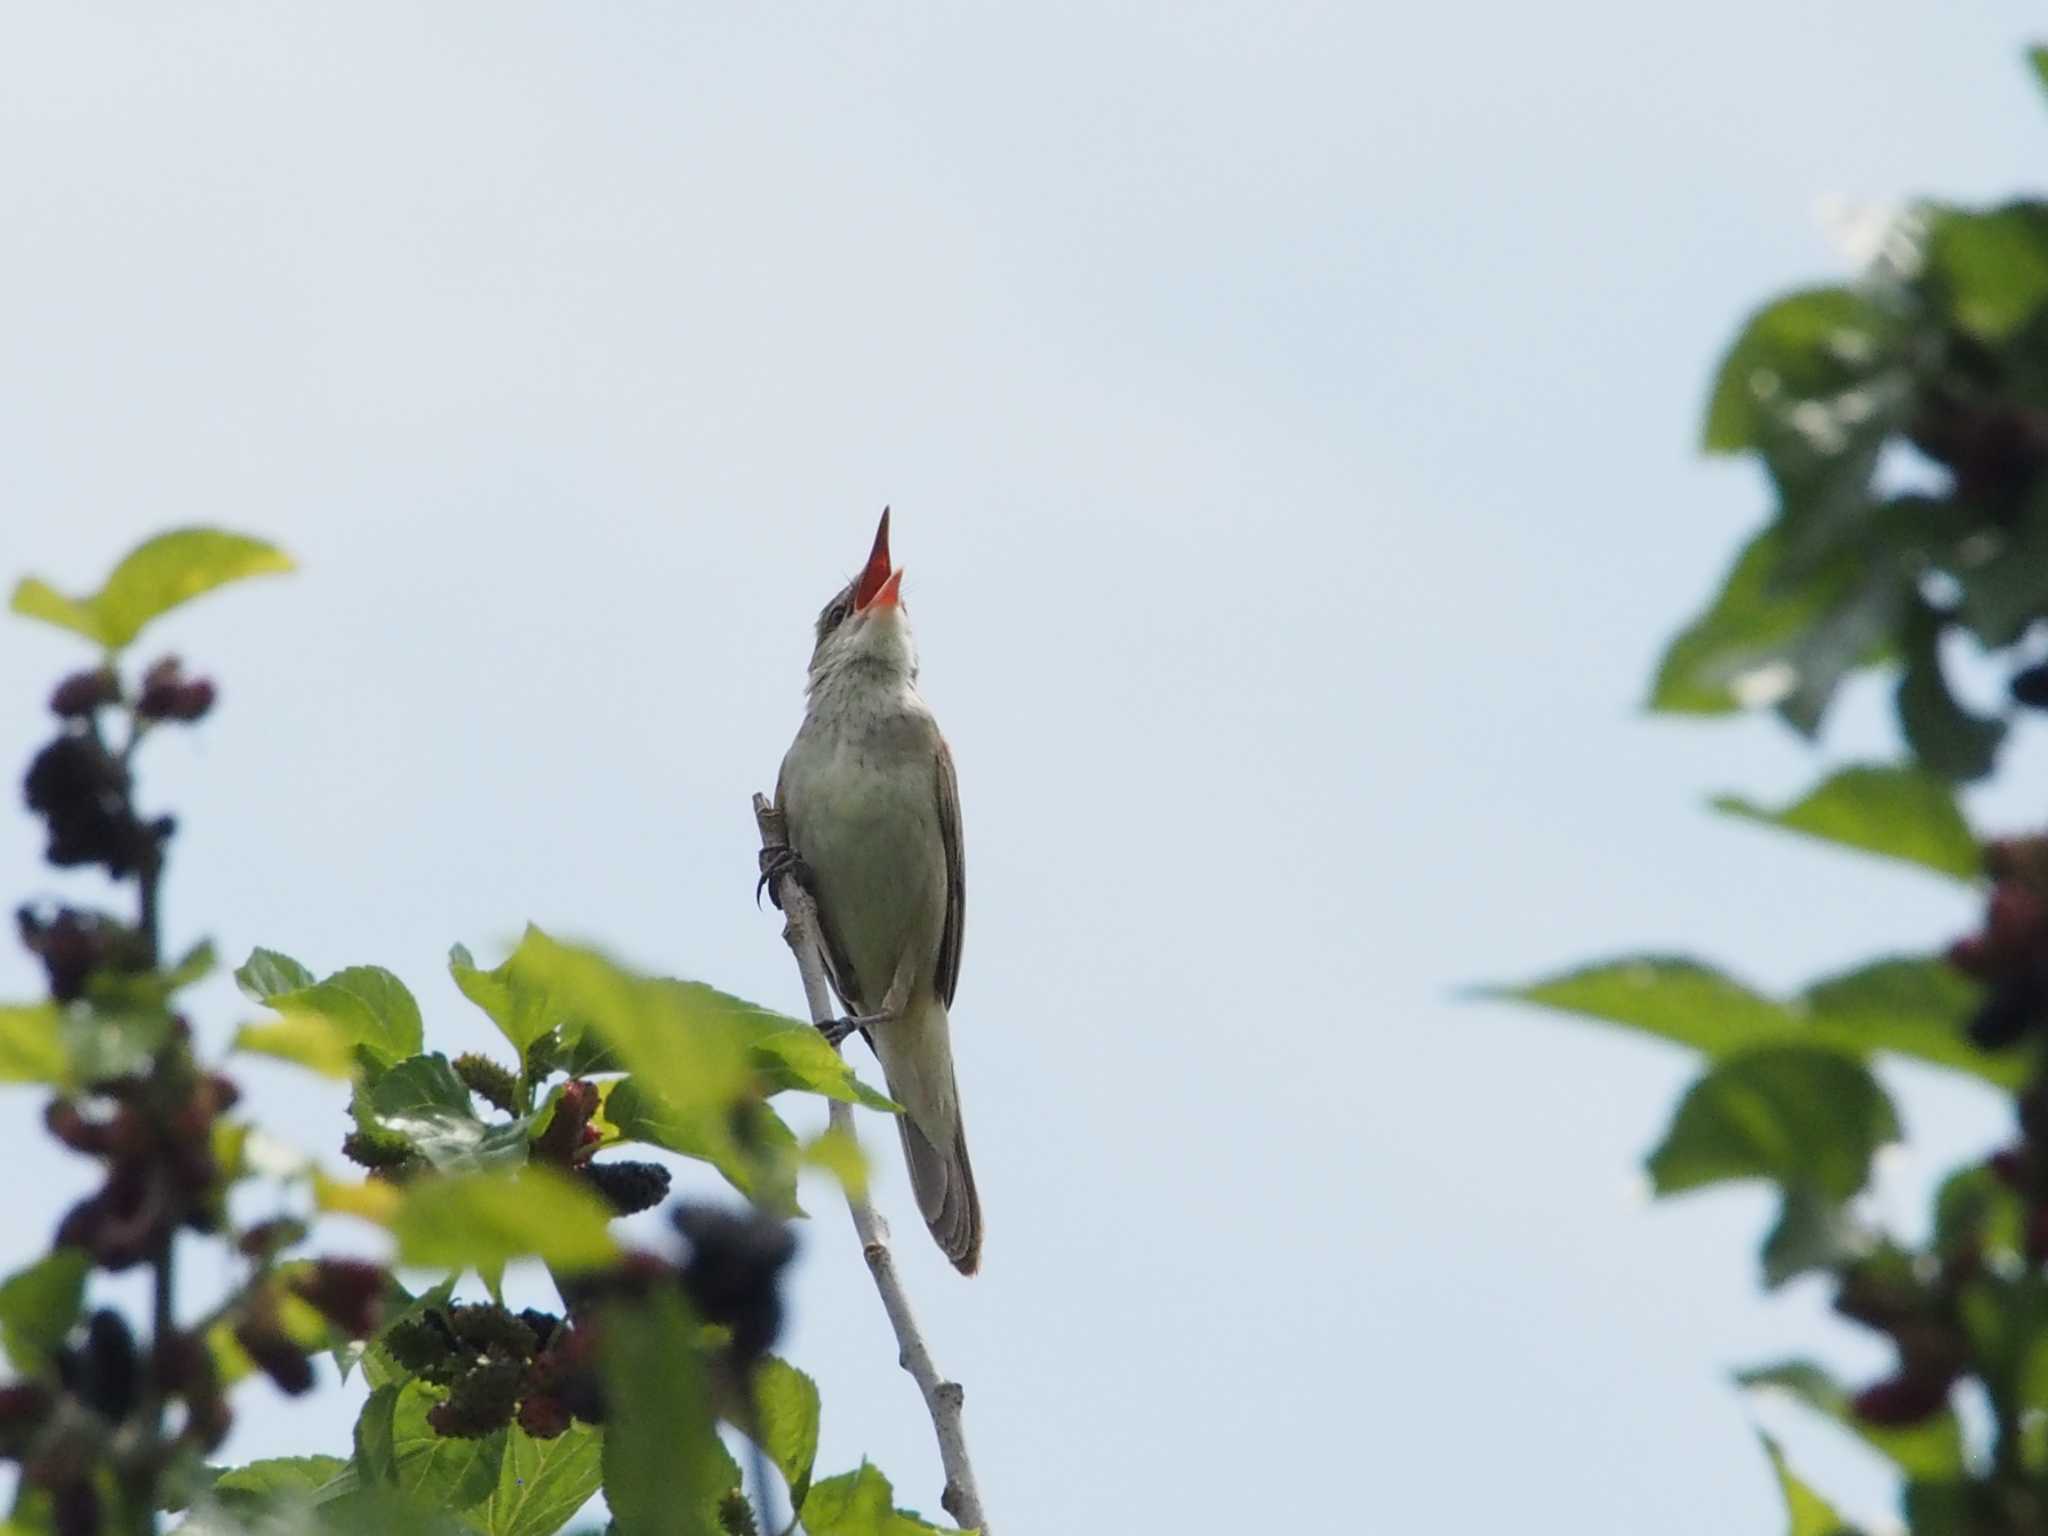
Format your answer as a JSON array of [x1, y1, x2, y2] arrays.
[[1649, 1044, 1898, 1200]]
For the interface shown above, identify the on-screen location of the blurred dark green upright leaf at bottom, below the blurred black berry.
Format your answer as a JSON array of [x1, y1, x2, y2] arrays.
[[602, 1290, 729, 1536]]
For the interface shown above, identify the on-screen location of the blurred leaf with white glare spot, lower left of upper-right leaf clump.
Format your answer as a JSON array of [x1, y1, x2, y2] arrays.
[[1651, 526, 1903, 733]]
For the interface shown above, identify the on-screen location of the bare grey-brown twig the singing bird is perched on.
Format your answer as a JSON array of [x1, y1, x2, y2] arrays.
[[754, 795, 989, 1536]]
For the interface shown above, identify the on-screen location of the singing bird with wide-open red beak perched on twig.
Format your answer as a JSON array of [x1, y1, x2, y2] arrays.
[[764, 508, 981, 1274]]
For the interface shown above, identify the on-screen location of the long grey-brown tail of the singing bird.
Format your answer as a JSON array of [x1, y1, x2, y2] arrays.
[[874, 999, 981, 1274]]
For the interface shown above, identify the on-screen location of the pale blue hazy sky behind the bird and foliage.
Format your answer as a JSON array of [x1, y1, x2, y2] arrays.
[[0, 0, 2048, 1536]]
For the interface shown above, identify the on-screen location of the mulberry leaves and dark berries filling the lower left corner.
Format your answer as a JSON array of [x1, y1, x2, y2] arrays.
[[0, 528, 958, 1536]]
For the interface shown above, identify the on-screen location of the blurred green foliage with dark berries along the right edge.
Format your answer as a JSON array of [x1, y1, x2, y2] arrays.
[[1489, 49, 2048, 1536]]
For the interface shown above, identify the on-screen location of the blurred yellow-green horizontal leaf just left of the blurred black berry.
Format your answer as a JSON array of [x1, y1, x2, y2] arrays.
[[391, 1167, 618, 1270]]
